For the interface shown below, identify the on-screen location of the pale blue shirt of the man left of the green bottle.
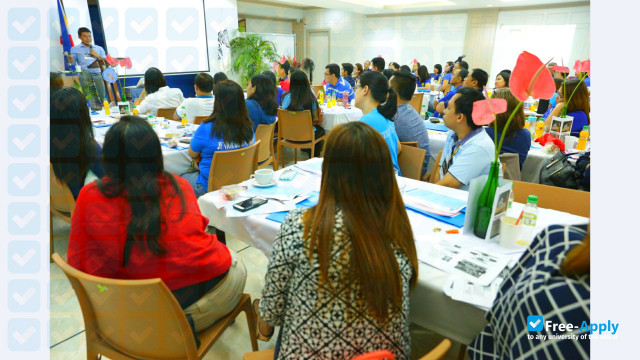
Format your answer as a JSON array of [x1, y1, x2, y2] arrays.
[[440, 128, 502, 190]]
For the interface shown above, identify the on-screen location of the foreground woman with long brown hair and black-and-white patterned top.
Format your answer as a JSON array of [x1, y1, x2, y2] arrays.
[[254, 121, 418, 360]]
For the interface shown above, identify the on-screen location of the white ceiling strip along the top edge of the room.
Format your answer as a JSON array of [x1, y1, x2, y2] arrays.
[[260, 0, 588, 14]]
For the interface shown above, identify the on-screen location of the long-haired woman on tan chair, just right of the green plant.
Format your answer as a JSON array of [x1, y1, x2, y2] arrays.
[[282, 70, 324, 156]]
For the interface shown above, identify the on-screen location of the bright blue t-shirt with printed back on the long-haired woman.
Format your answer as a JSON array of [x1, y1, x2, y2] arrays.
[[190, 121, 256, 189]]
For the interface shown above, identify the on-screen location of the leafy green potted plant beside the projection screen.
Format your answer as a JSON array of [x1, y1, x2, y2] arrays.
[[230, 34, 278, 87]]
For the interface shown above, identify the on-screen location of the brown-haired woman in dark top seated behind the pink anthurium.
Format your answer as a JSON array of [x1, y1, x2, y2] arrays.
[[485, 88, 531, 169]]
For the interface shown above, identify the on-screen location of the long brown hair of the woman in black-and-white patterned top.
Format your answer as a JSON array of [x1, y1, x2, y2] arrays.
[[302, 121, 418, 322]]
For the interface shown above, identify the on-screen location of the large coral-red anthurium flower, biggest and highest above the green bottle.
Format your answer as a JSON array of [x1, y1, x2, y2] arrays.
[[509, 51, 556, 101]]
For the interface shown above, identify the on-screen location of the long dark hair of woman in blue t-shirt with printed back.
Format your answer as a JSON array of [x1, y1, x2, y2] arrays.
[[204, 80, 253, 145]]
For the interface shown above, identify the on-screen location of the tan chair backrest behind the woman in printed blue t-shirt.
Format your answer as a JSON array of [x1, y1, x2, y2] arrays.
[[207, 140, 260, 192]]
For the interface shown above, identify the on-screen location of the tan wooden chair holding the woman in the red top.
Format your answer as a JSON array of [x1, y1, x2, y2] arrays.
[[53, 253, 258, 360]]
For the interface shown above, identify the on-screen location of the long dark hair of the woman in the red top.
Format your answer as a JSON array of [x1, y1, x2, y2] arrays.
[[98, 116, 186, 266]]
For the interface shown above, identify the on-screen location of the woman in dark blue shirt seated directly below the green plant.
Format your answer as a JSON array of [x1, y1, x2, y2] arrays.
[[246, 75, 278, 132]]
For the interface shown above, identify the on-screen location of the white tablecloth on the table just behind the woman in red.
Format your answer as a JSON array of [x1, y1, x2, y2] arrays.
[[91, 108, 198, 175]]
